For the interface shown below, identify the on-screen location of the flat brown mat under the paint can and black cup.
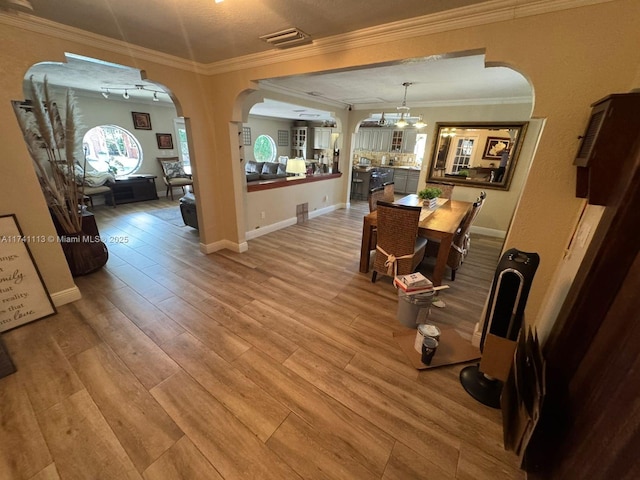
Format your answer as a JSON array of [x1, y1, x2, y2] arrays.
[[393, 322, 481, 370]]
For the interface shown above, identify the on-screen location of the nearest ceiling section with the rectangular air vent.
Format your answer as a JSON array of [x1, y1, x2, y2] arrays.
[[11, 0, 496, 64]]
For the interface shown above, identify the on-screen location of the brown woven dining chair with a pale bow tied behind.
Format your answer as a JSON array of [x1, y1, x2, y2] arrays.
[[371, 201, 427, 282]]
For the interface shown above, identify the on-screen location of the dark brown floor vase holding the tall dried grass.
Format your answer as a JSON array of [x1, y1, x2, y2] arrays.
[[60, 232, 109, 277]]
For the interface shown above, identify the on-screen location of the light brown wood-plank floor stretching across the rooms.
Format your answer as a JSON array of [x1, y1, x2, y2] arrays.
[[0, 199, 524, 480]]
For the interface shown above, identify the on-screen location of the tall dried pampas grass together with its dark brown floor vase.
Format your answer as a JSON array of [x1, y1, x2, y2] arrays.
[[13, 76, 109, 276]]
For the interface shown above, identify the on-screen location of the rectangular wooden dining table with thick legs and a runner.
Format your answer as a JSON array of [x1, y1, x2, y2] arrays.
[[360, 194, 473, 286]]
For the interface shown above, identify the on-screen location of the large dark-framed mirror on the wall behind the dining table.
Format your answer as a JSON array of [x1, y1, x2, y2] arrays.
[[428, 122, 528, 190]]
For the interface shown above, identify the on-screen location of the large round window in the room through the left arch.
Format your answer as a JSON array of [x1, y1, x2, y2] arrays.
[[82, 125, 142, 175]]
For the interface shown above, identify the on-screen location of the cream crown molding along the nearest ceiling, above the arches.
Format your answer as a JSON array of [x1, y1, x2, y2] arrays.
[[0, 0, 616, 75]]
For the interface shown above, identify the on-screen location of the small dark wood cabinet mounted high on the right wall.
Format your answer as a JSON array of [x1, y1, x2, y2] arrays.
[[574, 92, 640, 205]]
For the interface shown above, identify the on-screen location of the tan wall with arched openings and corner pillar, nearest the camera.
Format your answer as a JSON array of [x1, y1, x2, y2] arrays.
[[0, 0, 640, 334]]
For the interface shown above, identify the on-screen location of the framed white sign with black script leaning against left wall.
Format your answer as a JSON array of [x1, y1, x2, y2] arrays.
[[0, 214, 56, 332]]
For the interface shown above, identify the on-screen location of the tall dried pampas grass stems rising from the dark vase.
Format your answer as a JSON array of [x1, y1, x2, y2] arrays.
[[13, 76, 82, 234]]
